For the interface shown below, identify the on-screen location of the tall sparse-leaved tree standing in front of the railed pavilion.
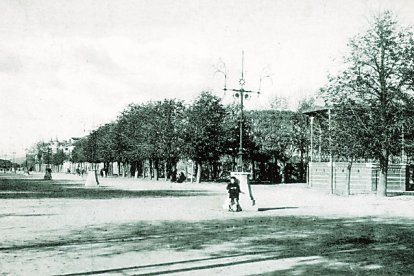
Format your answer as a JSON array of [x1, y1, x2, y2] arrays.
[[323, 11, 414, 195]]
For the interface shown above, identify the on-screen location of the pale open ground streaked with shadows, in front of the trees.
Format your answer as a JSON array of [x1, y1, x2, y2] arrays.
[[0, 174, 414, 275]]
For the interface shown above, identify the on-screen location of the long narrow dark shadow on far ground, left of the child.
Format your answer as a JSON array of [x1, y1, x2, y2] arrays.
[[0, 178, 212, 199]]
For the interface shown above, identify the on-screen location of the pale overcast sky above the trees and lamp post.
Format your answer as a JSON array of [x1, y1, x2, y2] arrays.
[[0, 0, 414, 159]]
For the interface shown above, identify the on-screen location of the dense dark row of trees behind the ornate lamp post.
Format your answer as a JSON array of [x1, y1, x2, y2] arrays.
[[72, 92, 309, 182]]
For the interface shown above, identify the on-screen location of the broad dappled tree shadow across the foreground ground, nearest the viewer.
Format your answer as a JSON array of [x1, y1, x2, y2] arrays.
[[4, 217, 414, 275]]
